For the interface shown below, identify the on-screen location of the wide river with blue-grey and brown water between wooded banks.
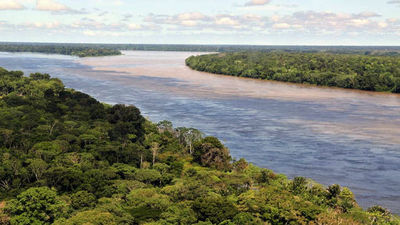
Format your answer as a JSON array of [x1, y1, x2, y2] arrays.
[[0, 51, 400, 214]]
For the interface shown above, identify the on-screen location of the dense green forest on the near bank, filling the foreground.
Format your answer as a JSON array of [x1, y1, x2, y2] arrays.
[[0, 68, 400, 225]]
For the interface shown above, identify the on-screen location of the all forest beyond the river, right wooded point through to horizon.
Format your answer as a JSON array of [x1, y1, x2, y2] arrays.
[[0, 42, 400, 93]]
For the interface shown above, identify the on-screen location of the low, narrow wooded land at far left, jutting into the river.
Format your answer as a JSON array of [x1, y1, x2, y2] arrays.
[[0, 43, 121, 57]]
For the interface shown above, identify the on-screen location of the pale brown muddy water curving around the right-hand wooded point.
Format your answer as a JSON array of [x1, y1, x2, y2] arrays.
[[78, 51, 400, 103]]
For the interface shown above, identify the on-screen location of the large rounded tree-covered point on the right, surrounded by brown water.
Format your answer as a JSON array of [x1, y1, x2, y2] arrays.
[[186, 51, 400, 93]]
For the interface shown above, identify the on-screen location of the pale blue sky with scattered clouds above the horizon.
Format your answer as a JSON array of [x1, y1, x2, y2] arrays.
[[0, 0, 400, 46]]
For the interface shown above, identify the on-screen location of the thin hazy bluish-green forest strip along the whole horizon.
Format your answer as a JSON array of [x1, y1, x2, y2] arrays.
[[0, 42, 400, 56]]
